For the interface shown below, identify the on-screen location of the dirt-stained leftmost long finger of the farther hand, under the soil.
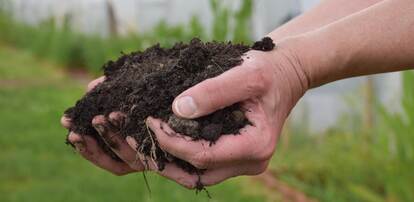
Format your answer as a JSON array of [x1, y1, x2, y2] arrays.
[[68, 132, 134, 175]]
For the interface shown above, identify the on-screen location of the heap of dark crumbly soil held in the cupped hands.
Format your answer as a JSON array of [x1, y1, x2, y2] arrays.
[[65, 38, 274, 174]]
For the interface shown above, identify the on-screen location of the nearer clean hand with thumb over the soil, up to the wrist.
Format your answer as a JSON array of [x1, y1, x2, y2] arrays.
[[142, 44, 309, 187]]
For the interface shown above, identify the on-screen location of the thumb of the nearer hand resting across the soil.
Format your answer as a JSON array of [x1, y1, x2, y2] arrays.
[[172, 52, 270, 118]]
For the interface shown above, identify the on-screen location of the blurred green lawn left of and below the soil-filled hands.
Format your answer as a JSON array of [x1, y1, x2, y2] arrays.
[[0, 45, 265, 202]]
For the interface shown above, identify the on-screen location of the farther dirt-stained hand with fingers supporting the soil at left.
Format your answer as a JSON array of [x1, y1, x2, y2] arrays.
[[61, 77, 202, 188]]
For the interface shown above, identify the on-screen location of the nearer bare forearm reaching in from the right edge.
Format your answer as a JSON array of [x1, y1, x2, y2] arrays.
[[282, 0, 414, 87]]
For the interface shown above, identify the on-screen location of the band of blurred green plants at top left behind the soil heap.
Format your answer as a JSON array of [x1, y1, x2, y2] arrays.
[[0, 0, 253, 73]]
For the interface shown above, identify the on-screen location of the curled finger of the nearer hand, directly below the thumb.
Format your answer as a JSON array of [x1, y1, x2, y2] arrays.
[[147, 113, 276, 169]]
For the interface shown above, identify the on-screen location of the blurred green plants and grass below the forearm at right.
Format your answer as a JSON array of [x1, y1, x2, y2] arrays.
[[273, 72, 414, 202]]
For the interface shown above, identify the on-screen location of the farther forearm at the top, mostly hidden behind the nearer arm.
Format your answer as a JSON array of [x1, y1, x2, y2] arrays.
[[269, 0, 383, 42]]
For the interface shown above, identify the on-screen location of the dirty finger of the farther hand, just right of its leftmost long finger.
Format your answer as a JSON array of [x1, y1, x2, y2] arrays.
[[92, 112, 144, 171]]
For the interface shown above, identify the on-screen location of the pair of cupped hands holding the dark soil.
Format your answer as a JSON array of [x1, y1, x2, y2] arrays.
[[61, 47, 309, 188]]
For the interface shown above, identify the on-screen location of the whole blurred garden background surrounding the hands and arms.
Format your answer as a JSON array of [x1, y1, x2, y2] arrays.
[[0, 0, 414, 202]]
